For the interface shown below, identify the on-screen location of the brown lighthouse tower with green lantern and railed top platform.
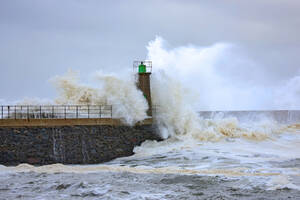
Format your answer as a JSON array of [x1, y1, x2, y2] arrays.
[[133, 60, 152, 116]]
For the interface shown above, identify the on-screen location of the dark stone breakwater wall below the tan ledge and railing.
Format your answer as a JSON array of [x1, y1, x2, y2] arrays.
[[0, 125, 161, 165]]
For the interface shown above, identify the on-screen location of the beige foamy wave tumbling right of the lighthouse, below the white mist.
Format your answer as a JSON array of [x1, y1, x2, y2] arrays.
[[152, 69, 290, 141]]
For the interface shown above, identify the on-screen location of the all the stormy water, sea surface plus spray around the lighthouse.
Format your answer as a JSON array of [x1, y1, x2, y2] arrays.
[[0, 34, 300, 200]]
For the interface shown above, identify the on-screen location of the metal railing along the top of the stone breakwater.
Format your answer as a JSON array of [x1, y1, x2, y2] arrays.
[[0, 105, 113, 120]]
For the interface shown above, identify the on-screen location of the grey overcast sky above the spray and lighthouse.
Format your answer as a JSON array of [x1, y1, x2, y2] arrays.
[[0, 0, 300, 100]]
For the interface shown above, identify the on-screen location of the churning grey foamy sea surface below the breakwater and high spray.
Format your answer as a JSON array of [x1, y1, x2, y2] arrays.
[[0, 111, 300, 199]]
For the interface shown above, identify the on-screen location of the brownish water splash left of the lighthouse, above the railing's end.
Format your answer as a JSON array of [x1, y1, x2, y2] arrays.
[[52, 71, 148, 125]]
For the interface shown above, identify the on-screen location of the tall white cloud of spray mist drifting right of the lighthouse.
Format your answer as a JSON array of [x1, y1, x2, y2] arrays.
[[147, 36, 300, 110]]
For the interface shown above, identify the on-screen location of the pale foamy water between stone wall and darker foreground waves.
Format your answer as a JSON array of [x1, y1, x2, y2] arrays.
[[0, 132, 300, 190]]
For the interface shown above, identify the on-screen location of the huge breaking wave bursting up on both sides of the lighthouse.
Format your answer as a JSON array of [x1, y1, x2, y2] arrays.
[[3, 37, 300, 141]]
